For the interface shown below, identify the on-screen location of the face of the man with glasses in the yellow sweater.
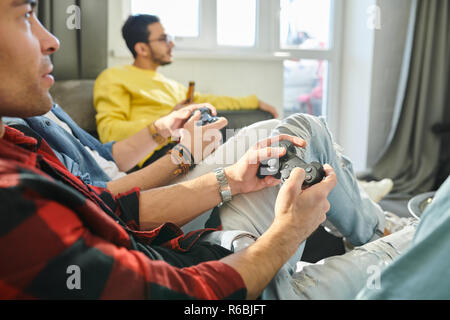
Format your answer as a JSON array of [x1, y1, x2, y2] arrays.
[[147, 22, 174, 66]]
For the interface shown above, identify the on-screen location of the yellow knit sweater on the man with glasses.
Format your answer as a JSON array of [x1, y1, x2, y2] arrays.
[[94, 65, 258, 164]]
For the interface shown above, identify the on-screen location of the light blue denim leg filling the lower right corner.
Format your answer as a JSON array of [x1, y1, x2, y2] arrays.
[[358, 177, 450, 299]]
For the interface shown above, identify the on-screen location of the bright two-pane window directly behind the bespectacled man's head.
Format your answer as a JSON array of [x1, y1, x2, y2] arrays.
[[128, 0, 260, 51]]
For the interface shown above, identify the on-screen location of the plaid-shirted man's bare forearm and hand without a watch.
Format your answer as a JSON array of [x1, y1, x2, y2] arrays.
[[221, 165, 336, 299]]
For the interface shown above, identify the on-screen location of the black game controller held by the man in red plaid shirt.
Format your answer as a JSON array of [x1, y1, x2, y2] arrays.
[[257, 140, 325, 189]]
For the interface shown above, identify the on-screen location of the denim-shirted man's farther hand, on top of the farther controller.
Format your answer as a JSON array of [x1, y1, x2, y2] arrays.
[[154, 103, 217, 139]]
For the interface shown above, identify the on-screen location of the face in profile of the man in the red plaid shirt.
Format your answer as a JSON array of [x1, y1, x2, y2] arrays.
[[0, 0, 59, 118]]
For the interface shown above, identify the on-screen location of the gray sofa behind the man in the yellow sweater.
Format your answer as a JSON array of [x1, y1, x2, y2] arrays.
[[50, 80, 272, 137]]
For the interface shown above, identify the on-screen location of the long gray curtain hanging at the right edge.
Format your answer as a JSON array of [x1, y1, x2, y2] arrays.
[[372, 0, 450, 195]]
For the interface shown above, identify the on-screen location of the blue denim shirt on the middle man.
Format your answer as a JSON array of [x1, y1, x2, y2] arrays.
[[3, 105, 114, 188]]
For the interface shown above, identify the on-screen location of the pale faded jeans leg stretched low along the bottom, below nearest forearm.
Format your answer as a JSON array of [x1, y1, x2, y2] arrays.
[[292, 222, 417, 300]]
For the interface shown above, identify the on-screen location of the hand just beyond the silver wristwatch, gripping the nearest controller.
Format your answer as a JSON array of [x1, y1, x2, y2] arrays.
[[224, 134, 306, 195]]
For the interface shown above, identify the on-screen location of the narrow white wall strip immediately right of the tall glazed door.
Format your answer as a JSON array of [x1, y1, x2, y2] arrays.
[[336, 0, 375, 171]]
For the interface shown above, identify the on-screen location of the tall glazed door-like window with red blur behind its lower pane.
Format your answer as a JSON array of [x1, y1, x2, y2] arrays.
[[278, 0, 342, 127]]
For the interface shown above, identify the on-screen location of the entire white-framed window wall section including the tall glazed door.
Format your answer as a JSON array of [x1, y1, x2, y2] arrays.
[[119, 0, 343, 124]]
